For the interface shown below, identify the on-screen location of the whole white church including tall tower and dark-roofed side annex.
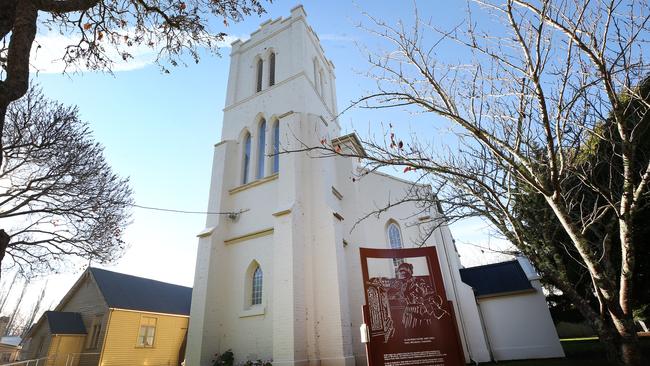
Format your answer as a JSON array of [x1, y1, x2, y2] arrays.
[[186, 6, 563, 366]]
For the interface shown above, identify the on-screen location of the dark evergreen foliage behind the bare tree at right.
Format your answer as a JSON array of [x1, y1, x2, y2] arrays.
[[515, 77, 650, 322]]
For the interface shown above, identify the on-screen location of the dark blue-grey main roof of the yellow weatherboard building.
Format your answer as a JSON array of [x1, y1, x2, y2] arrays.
[[89, 268, 192, 316]]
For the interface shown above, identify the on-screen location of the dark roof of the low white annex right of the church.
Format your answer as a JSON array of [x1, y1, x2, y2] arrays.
[[460, 260, 534, 297]]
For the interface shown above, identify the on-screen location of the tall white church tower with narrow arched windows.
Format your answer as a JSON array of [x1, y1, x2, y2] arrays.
[[186, 6, 358, 366]]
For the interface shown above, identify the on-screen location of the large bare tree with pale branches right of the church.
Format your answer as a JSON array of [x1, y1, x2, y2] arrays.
[[292, 0, 650, 365]]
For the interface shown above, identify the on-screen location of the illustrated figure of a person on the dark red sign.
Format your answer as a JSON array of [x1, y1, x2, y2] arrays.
[[391, 262, 449, 328]]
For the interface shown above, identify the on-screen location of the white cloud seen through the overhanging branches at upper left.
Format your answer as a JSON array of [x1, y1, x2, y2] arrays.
[[30, 32, 243, 73]]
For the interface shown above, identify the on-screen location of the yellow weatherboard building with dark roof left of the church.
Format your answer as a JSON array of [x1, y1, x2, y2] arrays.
[[21, 268, 192, 366]]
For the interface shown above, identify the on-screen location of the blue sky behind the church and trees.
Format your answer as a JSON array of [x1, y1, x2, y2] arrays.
[[6, 0, 512, 318]]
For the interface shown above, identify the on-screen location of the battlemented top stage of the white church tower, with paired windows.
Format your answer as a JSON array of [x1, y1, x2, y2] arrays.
[[225, 5, 337, 131]]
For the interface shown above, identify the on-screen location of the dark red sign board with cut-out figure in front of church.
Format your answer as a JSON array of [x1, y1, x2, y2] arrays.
[[361, 247, 465, 366]]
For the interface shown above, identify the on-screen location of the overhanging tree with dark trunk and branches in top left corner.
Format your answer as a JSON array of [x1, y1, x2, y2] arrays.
[[0, 0, 264, 165]]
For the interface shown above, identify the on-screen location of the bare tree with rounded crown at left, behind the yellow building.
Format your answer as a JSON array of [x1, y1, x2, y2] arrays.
[[0, 89, 132, 275]]
